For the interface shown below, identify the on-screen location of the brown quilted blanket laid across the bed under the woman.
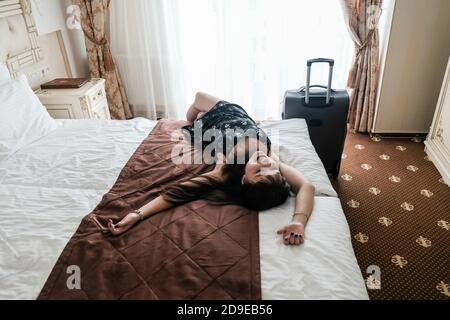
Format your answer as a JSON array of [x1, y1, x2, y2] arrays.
[[38, 120, 261, 299]]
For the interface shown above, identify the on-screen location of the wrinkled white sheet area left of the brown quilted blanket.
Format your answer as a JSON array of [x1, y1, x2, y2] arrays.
[[0, 119, 156, 299]]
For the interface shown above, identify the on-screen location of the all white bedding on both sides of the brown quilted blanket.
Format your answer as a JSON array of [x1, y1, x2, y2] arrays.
[[0, 118, 368, 299]]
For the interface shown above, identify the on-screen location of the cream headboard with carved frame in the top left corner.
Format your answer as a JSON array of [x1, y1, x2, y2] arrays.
[[0, 0, 41, 78]]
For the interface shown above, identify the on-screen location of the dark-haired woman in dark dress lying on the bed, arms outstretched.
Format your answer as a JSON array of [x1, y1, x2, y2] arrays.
[[108, 93, 315, 245]]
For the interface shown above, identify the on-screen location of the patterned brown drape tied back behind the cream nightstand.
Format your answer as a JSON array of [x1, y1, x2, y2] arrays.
[[76, 0, 133, 119]]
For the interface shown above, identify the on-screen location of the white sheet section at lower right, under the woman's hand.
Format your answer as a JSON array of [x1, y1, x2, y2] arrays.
[[259, 197, 369, 300]]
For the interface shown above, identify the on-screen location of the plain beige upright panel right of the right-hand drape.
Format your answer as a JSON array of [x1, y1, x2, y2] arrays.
[[373, 0, 450, 133]]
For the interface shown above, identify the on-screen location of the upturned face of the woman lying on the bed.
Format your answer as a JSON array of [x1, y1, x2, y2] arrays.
[[242, 151, 280, 183]]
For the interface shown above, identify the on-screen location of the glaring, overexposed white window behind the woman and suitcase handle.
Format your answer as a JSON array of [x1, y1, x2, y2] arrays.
[[173, 0, 354, 119]]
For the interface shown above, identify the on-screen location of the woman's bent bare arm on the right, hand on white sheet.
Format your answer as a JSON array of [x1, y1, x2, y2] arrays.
[[277, 162, 315, 245]]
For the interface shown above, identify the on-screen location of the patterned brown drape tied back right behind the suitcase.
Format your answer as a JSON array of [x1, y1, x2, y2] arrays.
[[340, 0, 383, 132]]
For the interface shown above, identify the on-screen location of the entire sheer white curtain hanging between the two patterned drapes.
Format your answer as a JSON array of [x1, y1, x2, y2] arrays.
[[111, 0, 354, 119]]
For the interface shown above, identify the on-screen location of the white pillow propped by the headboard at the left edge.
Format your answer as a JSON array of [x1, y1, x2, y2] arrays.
[[0, 75, 58, 160]]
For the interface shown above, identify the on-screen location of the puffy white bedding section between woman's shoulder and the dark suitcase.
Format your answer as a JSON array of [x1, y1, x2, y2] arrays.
[[261, 119, 337, 197]]
